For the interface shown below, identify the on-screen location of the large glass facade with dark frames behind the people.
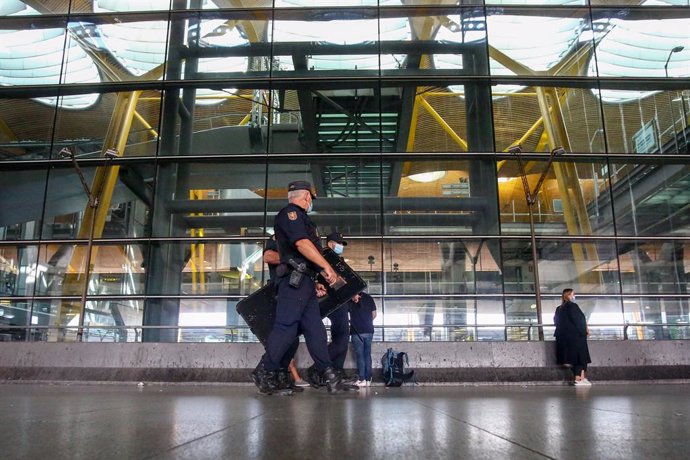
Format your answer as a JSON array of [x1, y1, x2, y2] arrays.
[[0, 0, 690, 342]]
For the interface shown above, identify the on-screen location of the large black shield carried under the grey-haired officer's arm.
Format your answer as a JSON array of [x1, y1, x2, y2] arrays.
[[236, 248, 367, 346]]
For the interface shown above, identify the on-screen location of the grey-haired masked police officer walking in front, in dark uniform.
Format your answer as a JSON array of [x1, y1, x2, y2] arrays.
[[259, 181, 342, 394]]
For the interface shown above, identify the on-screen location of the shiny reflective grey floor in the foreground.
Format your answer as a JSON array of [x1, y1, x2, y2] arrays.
[[0, 383, 690, 460]]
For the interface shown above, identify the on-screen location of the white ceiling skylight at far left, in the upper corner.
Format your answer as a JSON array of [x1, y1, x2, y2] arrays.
[[0, 0, 100, 109]]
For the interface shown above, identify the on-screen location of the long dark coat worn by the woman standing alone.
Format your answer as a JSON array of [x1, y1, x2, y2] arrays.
[[553, 302, 592, 365]]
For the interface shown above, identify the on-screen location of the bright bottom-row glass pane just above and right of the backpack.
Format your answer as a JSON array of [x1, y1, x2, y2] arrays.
[[382, 298, 505, 342]]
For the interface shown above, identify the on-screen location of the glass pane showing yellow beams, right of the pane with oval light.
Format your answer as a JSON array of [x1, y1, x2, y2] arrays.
[[498, 160, 614, 235]]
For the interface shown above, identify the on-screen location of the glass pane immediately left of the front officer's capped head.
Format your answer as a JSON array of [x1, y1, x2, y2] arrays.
[[152, 161, 266, 237]]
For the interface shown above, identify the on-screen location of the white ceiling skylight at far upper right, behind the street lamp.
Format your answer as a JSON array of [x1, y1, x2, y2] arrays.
[[588, 0, 690, 103]]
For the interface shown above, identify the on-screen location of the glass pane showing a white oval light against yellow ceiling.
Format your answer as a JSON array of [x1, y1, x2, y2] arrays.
[[384, 159, 498, 235]]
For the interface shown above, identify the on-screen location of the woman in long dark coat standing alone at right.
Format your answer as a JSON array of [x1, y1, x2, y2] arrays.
[[553, 289, 592, 386]]
